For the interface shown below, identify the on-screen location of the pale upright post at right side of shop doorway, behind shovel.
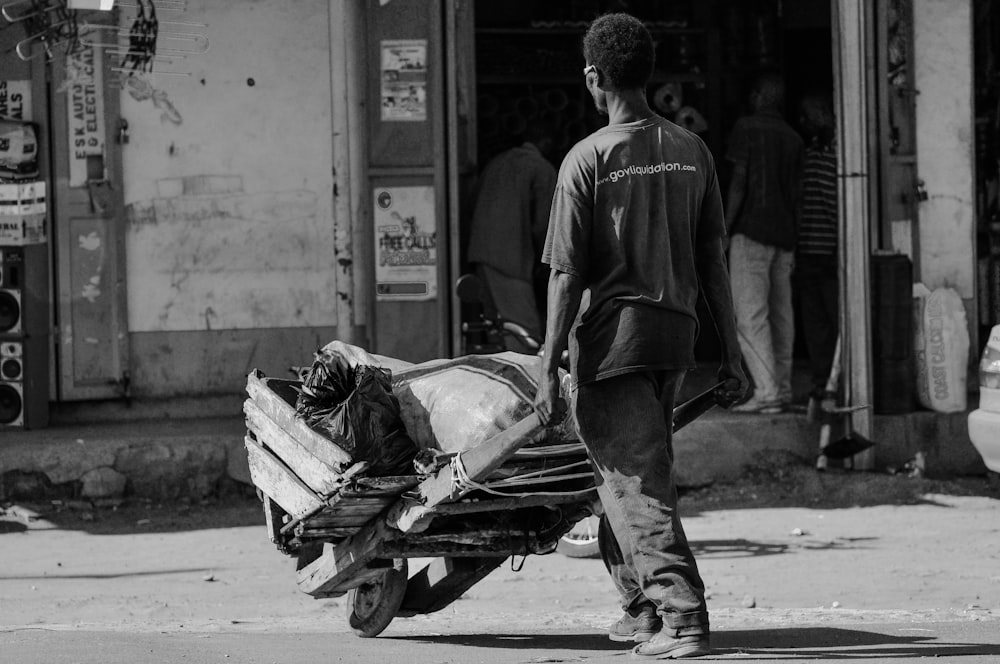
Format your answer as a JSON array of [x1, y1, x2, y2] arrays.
[[832, 0, 875, 469]]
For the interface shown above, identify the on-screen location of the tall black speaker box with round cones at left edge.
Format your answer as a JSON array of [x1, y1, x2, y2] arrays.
[[0, 244, 50, 429]]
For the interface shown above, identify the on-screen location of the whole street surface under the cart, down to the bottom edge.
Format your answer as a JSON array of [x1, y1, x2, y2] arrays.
[[0, 479, 1000, 664]]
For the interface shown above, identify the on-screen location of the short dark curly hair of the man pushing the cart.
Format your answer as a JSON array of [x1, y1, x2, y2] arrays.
[[583, 13, 656, 90]]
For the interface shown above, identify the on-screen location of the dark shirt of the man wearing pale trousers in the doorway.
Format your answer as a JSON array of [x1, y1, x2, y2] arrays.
[[726, 111, 803, 250]]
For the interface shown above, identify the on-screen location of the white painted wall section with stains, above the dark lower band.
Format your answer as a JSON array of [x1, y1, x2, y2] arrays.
[[122, 0, 336, 333]]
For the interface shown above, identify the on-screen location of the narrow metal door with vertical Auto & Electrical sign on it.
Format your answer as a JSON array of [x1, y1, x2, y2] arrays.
[[49, 40, 130, 401]]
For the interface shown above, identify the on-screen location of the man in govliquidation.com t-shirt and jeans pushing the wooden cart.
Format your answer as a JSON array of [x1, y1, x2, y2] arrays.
[[535, 14, 747, 658]]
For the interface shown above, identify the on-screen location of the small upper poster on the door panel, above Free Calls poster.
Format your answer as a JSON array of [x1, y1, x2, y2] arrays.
[[381, 39, 427, 122]]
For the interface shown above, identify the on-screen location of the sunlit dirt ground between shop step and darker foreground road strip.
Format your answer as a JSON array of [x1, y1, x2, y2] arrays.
[[0, 462, 1000, 634]]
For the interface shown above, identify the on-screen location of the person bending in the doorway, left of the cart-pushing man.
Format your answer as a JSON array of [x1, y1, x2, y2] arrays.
[[468, 120, 556, 352]]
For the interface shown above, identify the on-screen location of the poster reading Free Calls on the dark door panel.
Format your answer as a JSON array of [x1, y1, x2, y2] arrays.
[[374, 186, 437, 300]]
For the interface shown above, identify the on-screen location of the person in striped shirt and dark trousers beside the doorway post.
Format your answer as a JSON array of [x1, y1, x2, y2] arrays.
[[795, 94, 840, 403]]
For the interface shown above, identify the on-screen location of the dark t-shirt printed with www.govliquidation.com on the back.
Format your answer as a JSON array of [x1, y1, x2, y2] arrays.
[[542, 116, 725, 384]]
